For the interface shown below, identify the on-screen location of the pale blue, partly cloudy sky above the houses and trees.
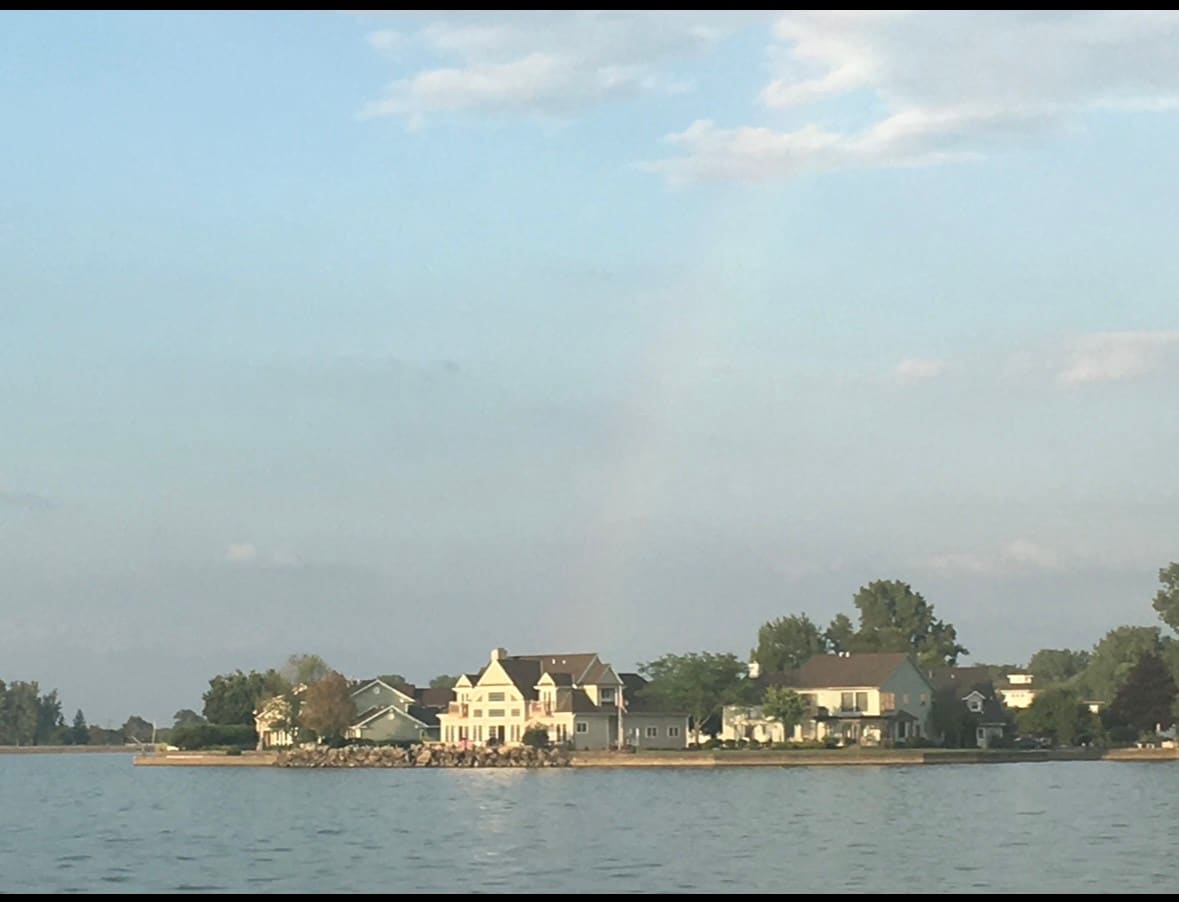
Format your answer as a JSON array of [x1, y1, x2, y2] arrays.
[[0, 12, 1179, 726]]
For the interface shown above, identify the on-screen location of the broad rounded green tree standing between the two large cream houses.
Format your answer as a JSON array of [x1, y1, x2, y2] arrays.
[[639, 652, 749, 744]]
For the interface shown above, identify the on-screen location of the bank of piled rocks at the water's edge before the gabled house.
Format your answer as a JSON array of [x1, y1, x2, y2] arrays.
[[275, 744, 569, 768]]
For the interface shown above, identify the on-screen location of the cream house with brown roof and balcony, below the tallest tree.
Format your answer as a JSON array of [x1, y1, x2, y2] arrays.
[[720, 653, 933, 745]]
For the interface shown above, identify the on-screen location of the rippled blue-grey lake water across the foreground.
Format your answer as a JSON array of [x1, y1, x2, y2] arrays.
[[0, 755, 1179, 893]]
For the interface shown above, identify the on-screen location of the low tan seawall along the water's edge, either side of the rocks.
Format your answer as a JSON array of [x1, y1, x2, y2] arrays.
[[129, 746, 1179, 770]]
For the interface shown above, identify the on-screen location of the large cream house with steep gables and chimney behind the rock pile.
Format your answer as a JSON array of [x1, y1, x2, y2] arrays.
[[439, 648, 687, 749]]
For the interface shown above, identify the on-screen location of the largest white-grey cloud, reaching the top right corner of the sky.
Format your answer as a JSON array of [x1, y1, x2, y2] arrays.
[[641, 11, 1179, 183]]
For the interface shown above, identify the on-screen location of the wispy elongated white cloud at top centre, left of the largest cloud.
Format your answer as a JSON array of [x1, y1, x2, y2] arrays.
[[361, 12, 727, 125]]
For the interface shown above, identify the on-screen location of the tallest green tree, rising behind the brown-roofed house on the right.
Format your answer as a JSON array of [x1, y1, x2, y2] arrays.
[[850, 579, 969, 669]]
